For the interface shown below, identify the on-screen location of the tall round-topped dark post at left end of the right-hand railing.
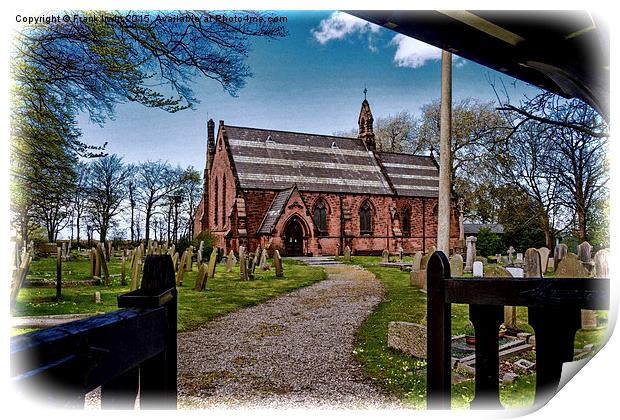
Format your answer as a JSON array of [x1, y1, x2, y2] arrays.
[[426, 251, 452, 410]]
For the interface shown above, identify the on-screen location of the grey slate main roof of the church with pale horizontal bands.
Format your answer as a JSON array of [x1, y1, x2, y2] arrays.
[[225, 125, 439, 197]]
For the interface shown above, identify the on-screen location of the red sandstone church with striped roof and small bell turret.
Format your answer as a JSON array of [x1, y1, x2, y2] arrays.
[[194, 100, 458, 256]]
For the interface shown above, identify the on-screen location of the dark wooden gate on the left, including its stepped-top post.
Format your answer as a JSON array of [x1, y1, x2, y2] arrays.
[[11, 255, 177, 409]]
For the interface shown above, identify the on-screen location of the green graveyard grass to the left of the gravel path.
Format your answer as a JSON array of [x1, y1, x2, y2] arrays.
[[12, 254, 326, 334]]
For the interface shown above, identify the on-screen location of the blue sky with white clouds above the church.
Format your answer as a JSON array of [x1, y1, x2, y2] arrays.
[[80, 11, 527, 169]]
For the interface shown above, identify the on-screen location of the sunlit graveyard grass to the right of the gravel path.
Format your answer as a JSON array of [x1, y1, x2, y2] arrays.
[[344, 257, 604, 409]]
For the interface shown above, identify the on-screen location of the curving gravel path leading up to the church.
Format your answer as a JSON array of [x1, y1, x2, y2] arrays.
[[178, 265, 400, 409]]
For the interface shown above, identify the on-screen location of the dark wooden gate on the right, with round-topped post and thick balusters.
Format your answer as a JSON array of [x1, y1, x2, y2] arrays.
[[427, 251, 609, 409]]
